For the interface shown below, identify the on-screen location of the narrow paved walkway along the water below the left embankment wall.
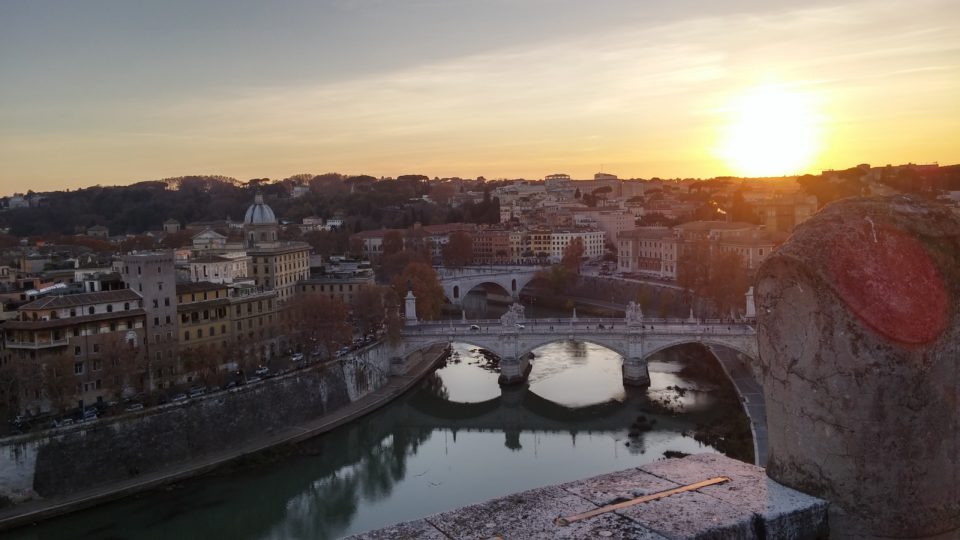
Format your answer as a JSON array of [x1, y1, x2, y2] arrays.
[[0, 347, 442, 531]]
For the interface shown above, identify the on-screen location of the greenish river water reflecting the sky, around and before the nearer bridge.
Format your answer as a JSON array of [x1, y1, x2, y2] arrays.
[[10, 336, 743, 539]]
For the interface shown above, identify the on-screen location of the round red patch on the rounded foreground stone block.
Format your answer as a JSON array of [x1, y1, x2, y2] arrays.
[[830, 220, 947, 345]]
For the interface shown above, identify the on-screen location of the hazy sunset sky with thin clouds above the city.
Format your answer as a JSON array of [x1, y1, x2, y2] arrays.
[[0, 0, 960, 194]]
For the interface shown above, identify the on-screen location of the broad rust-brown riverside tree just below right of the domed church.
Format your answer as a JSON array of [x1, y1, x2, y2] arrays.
[[286, 292, 353, 356]]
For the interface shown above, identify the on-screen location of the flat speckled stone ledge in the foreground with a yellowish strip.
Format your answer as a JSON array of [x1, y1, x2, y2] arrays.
[[350, 454, 828, 540]]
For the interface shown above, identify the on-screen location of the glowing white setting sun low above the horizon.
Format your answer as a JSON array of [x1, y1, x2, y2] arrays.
[[719, 85, 820, 177]]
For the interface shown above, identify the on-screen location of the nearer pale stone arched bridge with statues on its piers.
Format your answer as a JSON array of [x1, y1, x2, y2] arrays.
[[400, 292, 758, 386]]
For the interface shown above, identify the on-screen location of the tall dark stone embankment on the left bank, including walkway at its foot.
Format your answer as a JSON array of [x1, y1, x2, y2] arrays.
[[0, 347, 443, 530]]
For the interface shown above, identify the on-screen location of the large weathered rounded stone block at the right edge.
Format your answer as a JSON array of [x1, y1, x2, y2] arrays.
[[757, 197, 960, 538]]
